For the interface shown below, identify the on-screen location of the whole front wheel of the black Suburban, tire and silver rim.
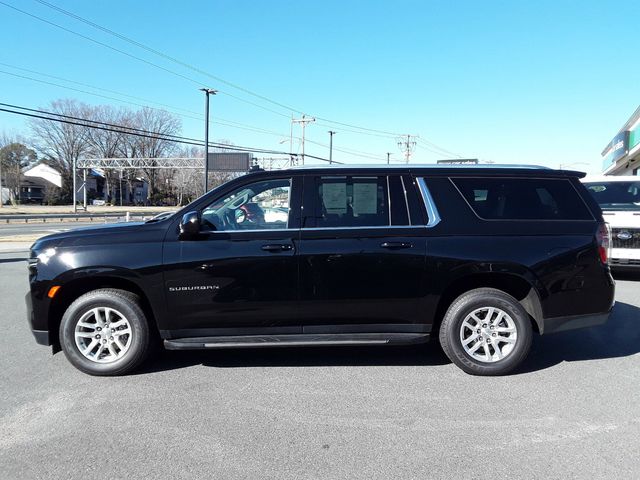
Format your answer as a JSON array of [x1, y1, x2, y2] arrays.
[[60, 288, 149, 375]]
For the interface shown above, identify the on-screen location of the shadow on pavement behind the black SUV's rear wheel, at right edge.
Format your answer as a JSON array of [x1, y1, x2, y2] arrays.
[[514, 302, 640, 374]]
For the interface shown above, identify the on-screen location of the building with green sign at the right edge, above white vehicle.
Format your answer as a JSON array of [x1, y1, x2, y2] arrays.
[[602, 107, 640, 175]]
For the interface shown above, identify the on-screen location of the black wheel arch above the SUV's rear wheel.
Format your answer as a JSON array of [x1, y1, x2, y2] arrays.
[[433, 272, 544, 334]]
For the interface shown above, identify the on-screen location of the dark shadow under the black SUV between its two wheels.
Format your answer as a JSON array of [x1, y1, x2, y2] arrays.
[[136, 342, 451, 374]]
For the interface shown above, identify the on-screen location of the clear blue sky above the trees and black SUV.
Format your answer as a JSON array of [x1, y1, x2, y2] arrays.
[[0, 0, 640, 173]]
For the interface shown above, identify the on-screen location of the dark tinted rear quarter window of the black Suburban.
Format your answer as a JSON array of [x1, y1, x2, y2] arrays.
[[450, 177, 593, 220]]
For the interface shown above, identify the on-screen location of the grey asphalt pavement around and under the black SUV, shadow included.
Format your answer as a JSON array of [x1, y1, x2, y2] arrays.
[[0, 254, 640, 480]]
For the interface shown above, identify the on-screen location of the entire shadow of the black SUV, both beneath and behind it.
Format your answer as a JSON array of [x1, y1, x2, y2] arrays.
[[134, 302, 640, 375]]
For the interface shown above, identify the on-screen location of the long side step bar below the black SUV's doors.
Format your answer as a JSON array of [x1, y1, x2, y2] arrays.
[[164, 333, 429, 350]]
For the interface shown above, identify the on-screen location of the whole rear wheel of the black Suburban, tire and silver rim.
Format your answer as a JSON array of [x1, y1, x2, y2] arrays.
[[439, 288, 532, 375]]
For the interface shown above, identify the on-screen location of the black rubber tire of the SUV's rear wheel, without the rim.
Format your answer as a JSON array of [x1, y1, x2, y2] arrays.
[[439, 288, 533, 376]]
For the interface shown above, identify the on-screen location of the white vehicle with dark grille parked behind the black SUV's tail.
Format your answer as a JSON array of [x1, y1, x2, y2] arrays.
[[582, 176, 640, 269]]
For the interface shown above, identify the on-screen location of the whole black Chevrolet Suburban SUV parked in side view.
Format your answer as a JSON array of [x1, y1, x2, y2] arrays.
[[27, 166, 614, 375]]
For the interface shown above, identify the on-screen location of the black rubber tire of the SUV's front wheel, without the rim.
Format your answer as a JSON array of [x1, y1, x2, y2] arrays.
[[60, 288, 149, 376]]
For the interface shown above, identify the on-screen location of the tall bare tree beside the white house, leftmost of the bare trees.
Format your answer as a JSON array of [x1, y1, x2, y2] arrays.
[[29, 99, 89, 201]]
